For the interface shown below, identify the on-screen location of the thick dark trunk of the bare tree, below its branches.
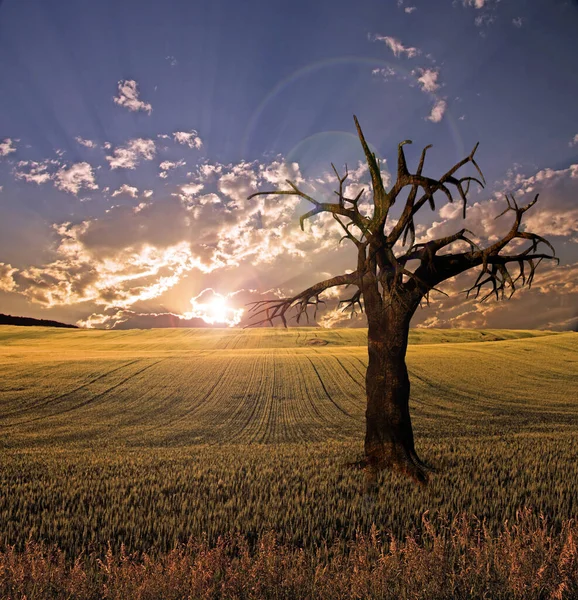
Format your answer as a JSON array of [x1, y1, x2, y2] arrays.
[[365, 302, 427, 487]]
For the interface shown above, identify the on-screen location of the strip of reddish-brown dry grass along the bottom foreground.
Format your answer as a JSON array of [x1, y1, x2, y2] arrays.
[[0, 511, 578, 600]]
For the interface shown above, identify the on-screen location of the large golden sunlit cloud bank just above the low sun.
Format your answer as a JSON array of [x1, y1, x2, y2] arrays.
[[3, 161, 324, 318]]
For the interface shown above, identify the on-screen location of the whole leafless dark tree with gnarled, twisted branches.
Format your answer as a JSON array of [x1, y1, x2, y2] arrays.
[[249, 116, 558, 483]]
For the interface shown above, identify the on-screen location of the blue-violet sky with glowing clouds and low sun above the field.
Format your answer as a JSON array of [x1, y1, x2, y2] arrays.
[[0, 0, 578, 330]]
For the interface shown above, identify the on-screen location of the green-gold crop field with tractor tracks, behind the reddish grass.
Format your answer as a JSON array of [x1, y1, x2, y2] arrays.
[[0, 326, 578, 598]]
